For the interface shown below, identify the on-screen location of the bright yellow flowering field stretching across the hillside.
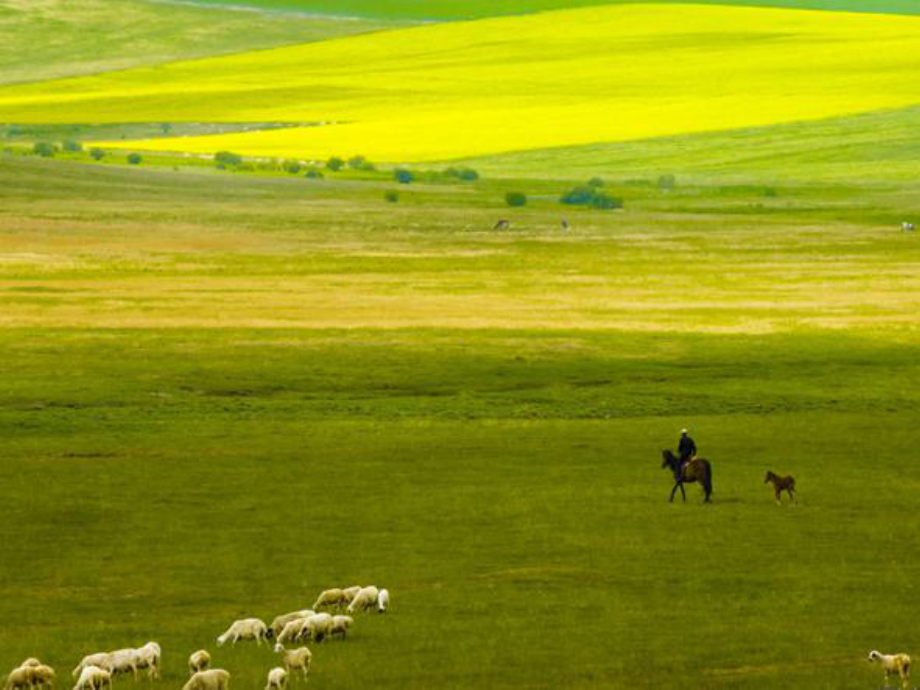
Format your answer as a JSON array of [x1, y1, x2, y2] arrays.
[[0, 5, 920, 162]]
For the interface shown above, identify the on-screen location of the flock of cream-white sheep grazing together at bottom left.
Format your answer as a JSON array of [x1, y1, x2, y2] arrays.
[[3, 586, 390, 690]]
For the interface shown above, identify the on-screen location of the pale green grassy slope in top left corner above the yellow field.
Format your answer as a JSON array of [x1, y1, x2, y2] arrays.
[[0, 0, 393, 84]]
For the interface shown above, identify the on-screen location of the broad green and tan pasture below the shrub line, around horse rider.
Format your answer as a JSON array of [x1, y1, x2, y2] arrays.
[[0, 148, 920, 689]]
